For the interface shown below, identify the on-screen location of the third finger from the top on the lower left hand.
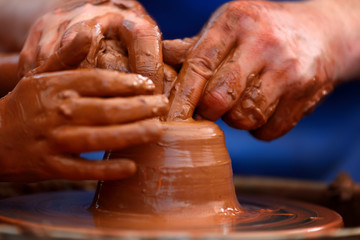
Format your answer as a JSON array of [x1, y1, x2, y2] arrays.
[[50, 120, 162, 153]]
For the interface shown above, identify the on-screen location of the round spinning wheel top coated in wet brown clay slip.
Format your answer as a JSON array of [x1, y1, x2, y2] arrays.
[[0, 188, 342, 235]]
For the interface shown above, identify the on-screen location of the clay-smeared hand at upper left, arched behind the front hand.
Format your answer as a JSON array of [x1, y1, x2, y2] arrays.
[[19, 0, 164, 93]]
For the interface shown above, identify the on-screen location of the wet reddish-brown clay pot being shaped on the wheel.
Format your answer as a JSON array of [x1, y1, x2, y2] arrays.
[[92, 120, 243, 227]]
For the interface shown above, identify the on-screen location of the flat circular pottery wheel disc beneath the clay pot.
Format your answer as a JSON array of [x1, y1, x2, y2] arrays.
[[0, 191, 342, 237]]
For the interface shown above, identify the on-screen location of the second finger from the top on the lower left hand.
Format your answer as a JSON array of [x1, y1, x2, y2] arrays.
[[59, 95, 169, 125]]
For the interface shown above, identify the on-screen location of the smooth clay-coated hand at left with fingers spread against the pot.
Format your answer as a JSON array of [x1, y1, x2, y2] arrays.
[[0, 69, 168, 181]]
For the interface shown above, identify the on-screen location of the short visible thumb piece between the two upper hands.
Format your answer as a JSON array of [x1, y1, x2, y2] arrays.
[[163, 36, 199, 66]]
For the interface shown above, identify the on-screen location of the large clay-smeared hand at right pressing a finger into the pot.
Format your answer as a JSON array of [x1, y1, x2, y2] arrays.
[[164, 1, 360, 140]]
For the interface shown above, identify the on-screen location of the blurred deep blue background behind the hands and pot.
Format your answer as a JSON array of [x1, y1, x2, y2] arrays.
[[83, 0, 360, 181]]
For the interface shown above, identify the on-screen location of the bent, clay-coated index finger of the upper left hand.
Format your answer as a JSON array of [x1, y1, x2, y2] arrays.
[[97, 12, 164, 93]]
